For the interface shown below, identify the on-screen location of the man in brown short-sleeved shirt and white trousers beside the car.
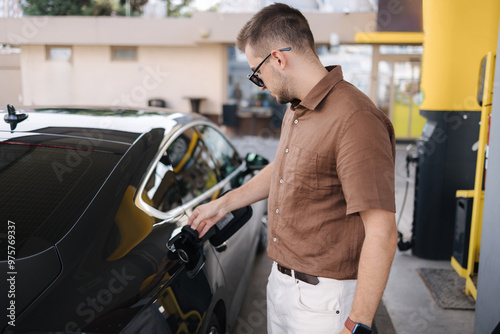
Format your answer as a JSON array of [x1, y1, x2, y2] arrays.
[[188, 3, 397, 334]]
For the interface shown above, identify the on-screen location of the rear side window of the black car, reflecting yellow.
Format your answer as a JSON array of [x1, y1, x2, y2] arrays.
[[167, 128, 217, 203]]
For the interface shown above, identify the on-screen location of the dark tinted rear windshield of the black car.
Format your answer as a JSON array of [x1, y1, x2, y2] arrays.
[[0, 142, 121, 260]]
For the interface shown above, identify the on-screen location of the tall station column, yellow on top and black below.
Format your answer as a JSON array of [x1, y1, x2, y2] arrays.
[[412, 0, 500, 260]]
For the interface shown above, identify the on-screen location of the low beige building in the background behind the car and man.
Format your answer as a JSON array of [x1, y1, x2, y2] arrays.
[[0, 12, 404, 133]]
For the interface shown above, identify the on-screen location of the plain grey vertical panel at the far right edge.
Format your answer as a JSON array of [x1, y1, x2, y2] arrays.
[[474, 22, 500, 334]]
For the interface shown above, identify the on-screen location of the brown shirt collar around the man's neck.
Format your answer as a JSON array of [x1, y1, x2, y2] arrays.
[[291, 65, 344, 111]]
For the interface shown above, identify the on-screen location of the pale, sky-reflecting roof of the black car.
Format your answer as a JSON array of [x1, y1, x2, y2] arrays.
[[0, 106, 204, 144]]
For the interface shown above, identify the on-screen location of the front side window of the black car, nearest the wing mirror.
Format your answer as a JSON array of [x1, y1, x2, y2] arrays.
[[199, 125, 242, 179]]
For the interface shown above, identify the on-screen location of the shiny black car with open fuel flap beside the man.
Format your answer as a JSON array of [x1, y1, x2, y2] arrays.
[[0, 105, 267, 333]]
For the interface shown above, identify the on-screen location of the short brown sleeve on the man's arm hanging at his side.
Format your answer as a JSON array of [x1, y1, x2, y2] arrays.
[[337, 110, 396, 214]]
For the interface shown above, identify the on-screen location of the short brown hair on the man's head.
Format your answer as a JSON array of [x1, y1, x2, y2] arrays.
[[236, 3, 316, 57]]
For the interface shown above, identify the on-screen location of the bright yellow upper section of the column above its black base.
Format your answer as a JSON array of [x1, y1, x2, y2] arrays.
[[420, 0, 500, 111]]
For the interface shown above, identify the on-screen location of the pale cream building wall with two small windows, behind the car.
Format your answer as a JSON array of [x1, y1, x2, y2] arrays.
[[21, 44, 227, 114]]
